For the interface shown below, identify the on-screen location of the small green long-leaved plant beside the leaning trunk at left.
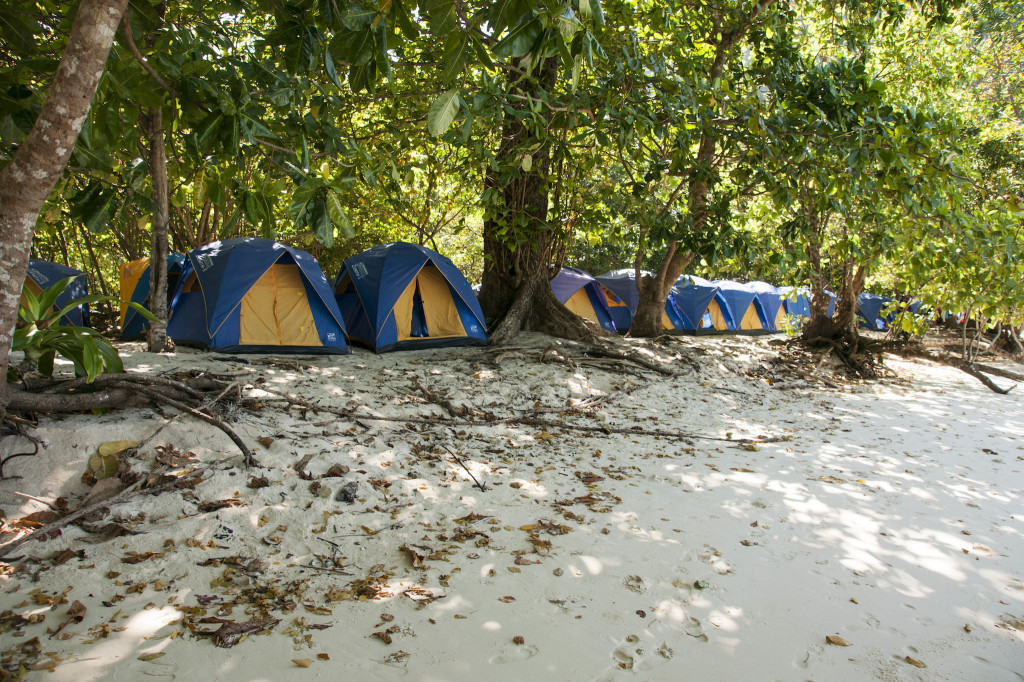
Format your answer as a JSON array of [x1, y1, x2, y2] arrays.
[[7, 278, 157, 381]]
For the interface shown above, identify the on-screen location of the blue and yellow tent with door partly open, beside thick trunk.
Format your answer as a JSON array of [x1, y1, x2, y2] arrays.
[[334, 242, 487, 353]]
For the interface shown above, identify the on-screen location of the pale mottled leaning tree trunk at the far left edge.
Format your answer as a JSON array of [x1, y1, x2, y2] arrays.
[[0, 0, 127, 404]]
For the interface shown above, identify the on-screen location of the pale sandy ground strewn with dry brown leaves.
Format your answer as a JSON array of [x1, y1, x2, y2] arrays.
[[0, 335, 1024, 682]]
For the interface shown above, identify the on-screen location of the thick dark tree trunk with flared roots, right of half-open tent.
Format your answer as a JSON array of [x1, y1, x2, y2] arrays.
[[480, 58, 596, 344]]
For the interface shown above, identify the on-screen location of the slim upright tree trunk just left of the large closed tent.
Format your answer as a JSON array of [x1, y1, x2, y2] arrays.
[[145, 108, 169, 353]]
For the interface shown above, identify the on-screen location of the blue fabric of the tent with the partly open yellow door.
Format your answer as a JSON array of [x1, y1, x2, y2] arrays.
[[334, 242, 488, 353]]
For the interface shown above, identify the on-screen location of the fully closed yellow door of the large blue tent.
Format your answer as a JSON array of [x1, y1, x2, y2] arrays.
[[239, 264, 322, 346]]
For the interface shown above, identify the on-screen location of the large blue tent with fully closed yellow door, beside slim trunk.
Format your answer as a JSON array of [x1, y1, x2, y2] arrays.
[[167, 237, 348, 353]]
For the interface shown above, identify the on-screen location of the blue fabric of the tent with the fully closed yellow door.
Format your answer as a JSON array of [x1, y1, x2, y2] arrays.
[[167, 237, 348, 354]]
